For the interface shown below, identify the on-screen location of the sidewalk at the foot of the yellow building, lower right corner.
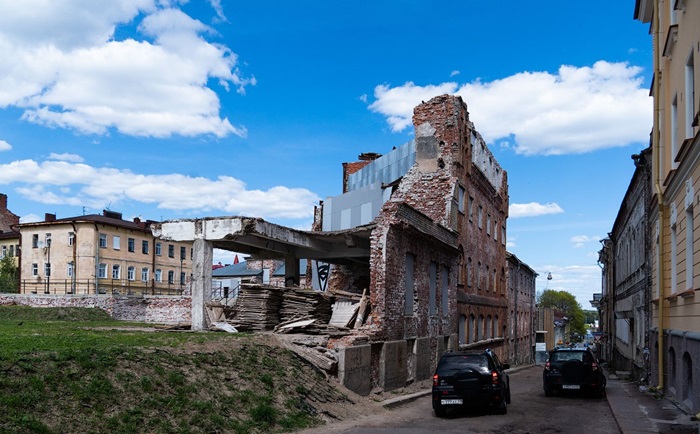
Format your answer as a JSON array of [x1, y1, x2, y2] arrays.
[[606, 369, 700, 434]]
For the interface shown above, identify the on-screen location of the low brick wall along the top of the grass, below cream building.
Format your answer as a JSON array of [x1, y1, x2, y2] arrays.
[[0, 294, 192, 324]]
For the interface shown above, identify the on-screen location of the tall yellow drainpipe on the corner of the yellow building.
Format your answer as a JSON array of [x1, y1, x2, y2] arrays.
[[652, 0, 673, 389]]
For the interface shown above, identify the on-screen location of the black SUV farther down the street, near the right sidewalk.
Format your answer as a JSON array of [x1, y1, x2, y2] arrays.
[[542, 348, 607, 396]]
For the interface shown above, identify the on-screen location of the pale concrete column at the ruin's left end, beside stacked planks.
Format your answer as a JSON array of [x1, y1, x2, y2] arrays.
[[192, 239, 214, 331]]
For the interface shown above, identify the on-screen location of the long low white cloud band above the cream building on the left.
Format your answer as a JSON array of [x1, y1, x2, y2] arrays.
[[0, 160, 320, 219]]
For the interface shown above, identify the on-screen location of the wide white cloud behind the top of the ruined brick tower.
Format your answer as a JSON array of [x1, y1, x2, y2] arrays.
[[369, 61, 652, 155]]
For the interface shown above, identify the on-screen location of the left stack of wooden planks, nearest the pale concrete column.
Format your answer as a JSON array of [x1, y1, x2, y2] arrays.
[[228, 285, 283, 331]]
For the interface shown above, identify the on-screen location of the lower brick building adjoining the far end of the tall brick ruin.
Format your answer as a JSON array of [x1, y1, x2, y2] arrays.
[[506, 252, 538, 365]]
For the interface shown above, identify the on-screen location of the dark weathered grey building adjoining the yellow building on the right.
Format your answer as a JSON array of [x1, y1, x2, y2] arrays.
[[599, 148, 652, 382]]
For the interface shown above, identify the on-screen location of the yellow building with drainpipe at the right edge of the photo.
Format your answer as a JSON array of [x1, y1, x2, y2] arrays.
[[634, 0, 700, 413]]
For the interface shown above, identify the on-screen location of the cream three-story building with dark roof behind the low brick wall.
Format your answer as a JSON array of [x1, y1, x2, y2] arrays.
[[19, 211, 192, 294]]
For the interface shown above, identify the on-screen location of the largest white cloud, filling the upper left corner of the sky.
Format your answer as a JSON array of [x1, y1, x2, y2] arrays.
[[0, 0, 255, 137]]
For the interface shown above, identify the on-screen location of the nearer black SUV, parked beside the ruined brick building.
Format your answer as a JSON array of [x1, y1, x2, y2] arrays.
[[433, 350, 510, 417]]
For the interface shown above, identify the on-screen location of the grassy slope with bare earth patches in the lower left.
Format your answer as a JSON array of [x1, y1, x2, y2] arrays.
[[0, 306, 347, 433]]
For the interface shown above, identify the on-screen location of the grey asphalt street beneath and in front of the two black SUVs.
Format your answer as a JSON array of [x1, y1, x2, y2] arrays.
[[296, 366, 620, 434]]
